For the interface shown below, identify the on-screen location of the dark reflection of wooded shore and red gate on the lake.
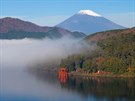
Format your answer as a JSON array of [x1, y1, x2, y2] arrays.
[[31, 70, 135, 101]]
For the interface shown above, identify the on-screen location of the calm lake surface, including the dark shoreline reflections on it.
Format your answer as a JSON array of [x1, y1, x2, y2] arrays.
[[0, 68, 135, 101]]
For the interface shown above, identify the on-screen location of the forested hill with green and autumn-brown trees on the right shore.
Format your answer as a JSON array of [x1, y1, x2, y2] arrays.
[[60, 28, 135, 76]]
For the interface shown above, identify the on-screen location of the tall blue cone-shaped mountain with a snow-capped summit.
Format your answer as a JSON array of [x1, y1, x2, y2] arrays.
[[56, 10, 125, 35]]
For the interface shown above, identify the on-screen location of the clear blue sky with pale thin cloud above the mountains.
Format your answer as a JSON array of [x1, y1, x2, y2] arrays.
[[0, 0, 135, 27]]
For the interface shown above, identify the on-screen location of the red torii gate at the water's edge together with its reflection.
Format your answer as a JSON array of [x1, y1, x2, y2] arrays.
[[59, 68, 68, 83]]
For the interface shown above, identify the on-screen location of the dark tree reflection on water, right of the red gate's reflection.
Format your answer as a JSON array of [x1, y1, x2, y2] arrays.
[[62, 77, 135, 99]]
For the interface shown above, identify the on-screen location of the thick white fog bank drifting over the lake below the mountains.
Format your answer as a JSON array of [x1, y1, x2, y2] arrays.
[[0, 38, 88, 67]]
